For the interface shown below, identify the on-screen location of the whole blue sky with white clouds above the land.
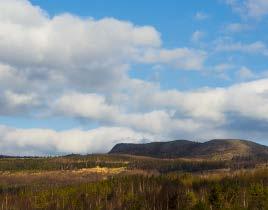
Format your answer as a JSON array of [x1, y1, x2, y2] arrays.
[[0, 0, 268, 155]]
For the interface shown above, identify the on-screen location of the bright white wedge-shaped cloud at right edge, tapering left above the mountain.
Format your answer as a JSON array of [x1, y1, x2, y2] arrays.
[[148, 79, 268, 123]]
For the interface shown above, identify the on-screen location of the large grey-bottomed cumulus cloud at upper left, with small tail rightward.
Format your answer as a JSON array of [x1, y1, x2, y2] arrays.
[[0, 0, 205, 95]]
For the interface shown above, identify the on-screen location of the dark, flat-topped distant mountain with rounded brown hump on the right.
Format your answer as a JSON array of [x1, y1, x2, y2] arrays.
[[109, 139, 268, 159]]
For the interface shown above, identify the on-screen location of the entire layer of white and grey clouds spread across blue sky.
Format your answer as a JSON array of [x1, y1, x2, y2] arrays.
[[0, 0, 268, 155]]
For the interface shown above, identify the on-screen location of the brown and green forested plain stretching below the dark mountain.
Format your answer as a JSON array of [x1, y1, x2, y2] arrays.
[[0, 155, 268, 210]]
